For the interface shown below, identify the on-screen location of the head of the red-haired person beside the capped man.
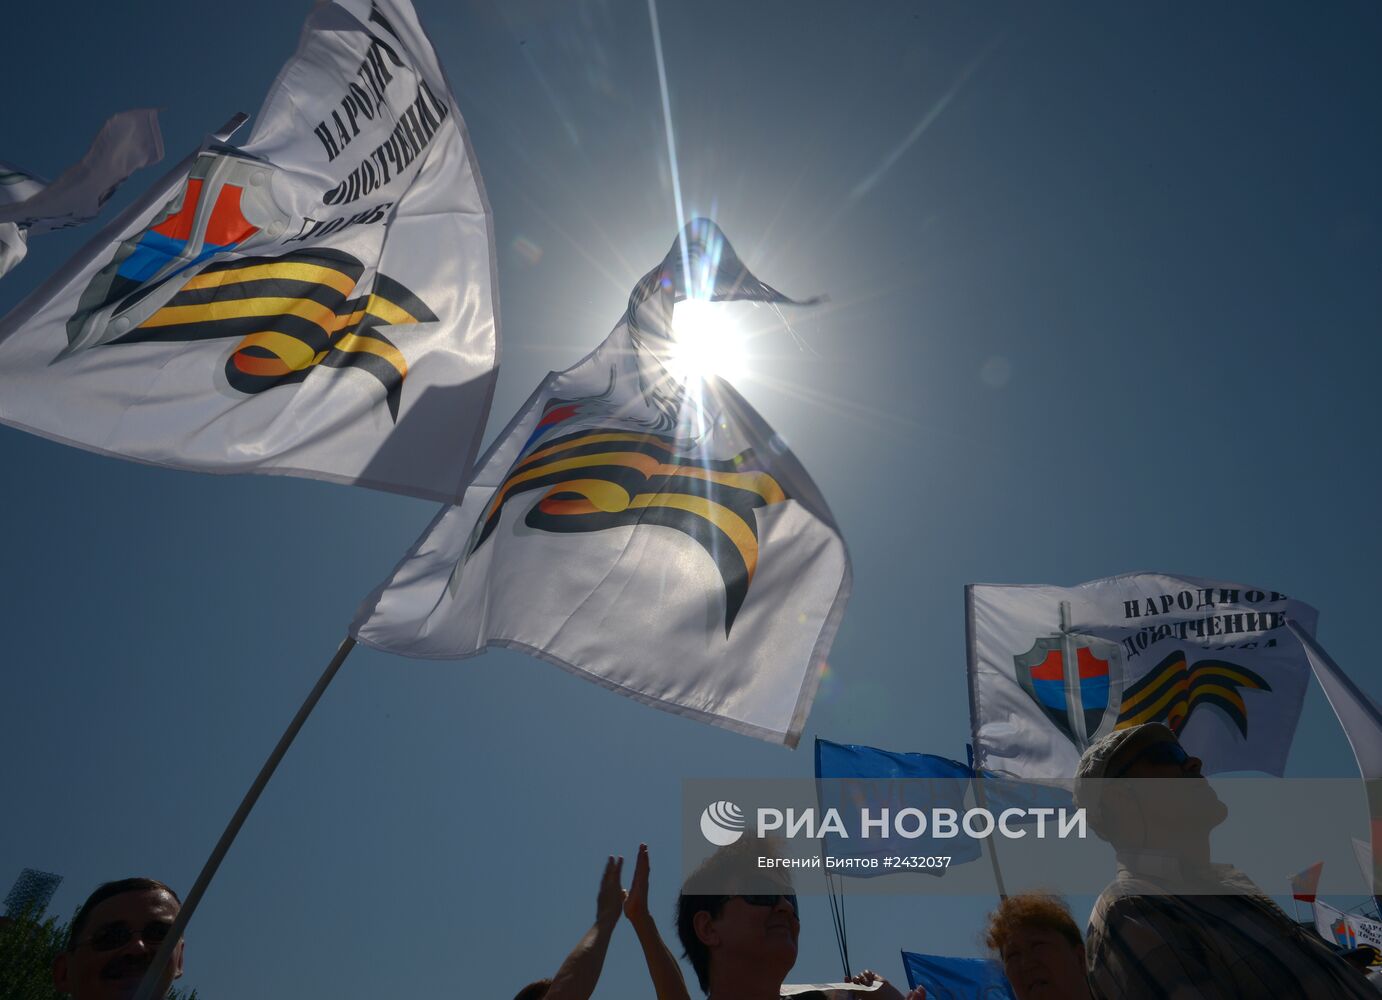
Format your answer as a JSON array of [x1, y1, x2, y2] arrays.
[[987, 892, 1089, 1000]]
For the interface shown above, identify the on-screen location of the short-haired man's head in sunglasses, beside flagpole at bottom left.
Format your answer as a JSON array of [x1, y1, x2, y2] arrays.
[[53, 878, 182, 1000]]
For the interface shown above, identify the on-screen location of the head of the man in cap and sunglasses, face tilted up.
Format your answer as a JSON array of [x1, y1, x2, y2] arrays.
[[1075, 722, 1229, 848]]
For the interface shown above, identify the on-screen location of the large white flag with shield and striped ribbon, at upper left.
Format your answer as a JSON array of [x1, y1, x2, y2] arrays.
[[0, 0, 496, 499]]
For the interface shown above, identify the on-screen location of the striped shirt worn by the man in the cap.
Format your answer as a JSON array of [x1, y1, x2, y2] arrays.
[[1085, 852, 1379, 1000]]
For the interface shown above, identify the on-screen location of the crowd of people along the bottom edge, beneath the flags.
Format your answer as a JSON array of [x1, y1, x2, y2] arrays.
[[53, 722, 1378, 1000]]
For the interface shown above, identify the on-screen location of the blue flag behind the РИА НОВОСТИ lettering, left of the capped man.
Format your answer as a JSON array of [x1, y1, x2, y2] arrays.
[[815, 739, 981, 877]]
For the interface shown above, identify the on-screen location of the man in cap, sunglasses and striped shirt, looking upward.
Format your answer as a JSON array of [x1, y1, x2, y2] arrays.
[[1075, 722, 1376, 1000]]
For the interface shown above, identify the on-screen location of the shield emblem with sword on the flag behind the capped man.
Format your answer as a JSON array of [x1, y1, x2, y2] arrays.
[[1013, 633, 1119, 746]]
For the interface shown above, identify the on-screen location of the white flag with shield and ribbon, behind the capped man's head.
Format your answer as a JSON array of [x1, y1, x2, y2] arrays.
[[966, 573, 1317, 780]]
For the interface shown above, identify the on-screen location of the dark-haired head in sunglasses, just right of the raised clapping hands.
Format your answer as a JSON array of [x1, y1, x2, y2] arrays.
[[676, 840, 802, 993]]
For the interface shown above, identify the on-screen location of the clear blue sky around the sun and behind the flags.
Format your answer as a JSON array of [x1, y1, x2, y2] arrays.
[[0, 0, 1382, 1000]]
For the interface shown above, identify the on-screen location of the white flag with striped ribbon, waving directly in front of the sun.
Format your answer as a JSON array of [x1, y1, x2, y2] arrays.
[[351, 220, 850, 746]]
